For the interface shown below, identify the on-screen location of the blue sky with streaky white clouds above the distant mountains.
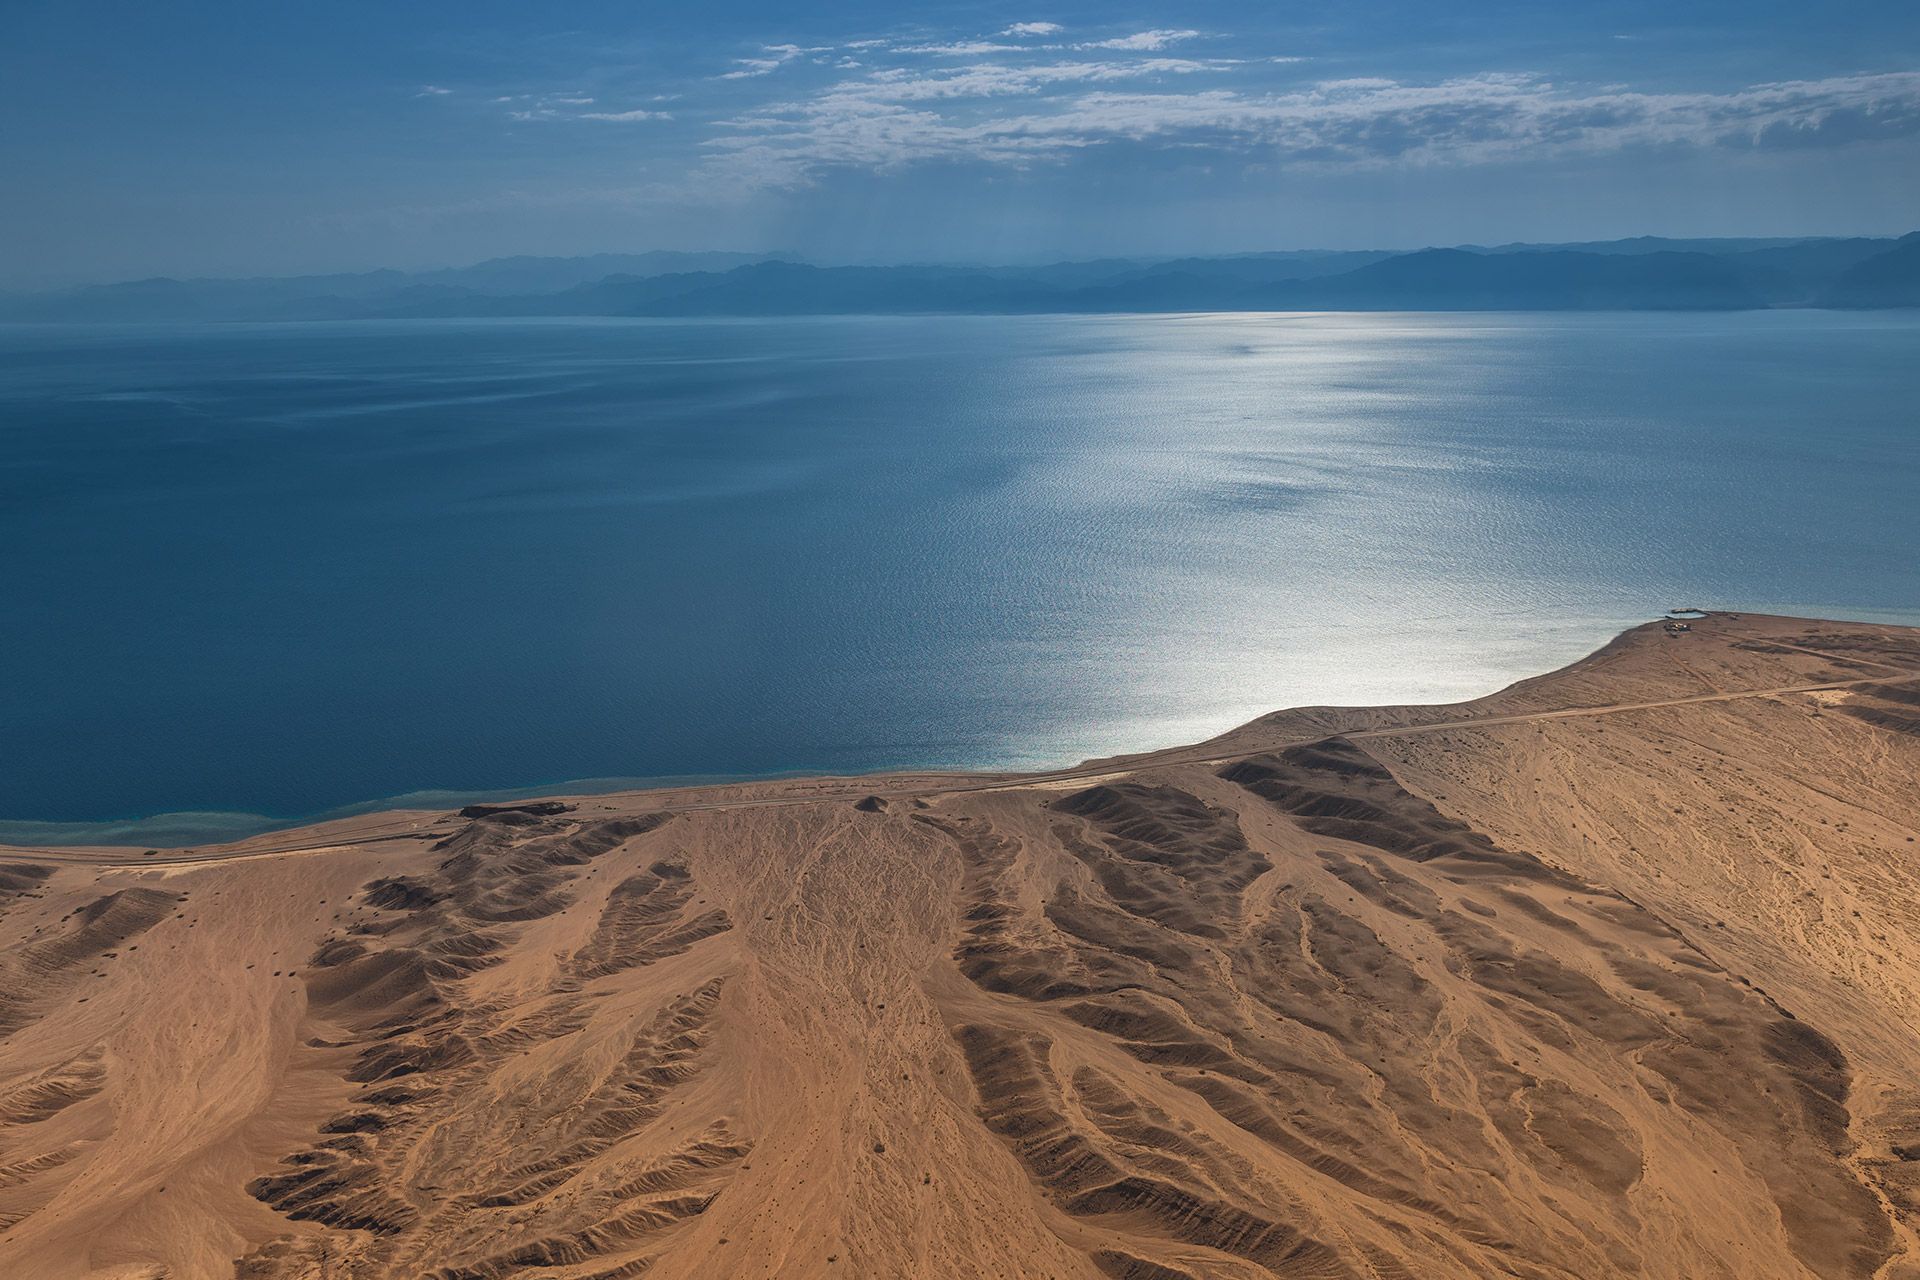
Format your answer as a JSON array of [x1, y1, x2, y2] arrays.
[[0, 0, 1920, 288]]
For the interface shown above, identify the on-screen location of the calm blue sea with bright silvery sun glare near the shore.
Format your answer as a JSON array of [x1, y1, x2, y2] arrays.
[[0, 313, 1920, 841]]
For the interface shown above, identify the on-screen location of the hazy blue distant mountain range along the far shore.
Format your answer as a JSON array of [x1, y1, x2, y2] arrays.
[[0, 232, 1920, 322]]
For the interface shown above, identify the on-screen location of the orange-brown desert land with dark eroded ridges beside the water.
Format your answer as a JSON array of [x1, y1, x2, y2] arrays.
[[0, 616, 1920, 1280]]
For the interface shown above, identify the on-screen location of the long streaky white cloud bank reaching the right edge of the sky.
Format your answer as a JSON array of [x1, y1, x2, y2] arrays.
[[707, 58, 1920, 186]]
